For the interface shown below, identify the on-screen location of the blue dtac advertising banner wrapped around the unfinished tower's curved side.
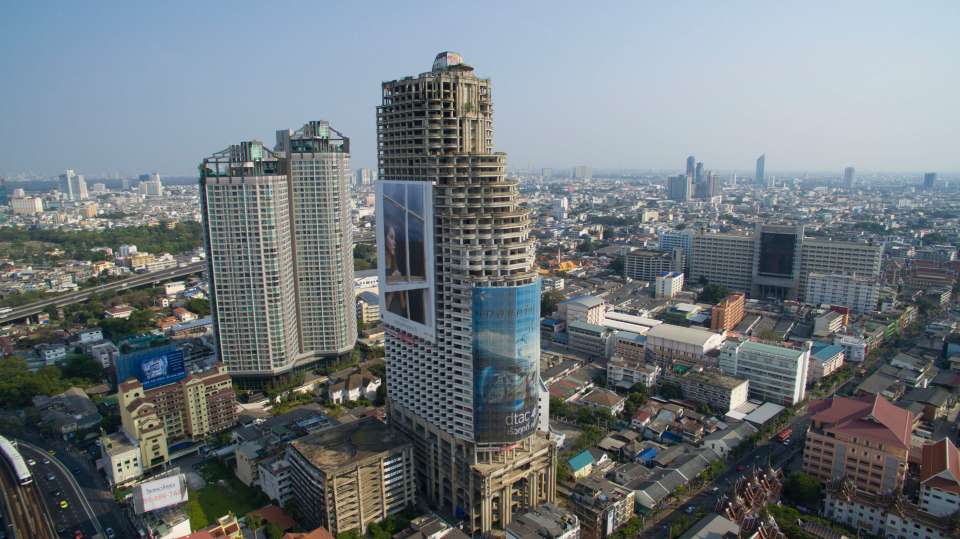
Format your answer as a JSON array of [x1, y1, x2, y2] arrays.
[[473, 280, 540, 443]]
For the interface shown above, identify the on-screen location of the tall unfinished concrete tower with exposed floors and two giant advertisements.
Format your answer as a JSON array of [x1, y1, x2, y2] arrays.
[[376, 52, 556, 536]]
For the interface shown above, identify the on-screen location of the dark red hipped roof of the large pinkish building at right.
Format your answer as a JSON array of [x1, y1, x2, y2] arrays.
[[810, 395, 913, 449]]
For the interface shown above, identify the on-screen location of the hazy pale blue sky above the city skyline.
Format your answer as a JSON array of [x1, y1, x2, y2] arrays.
[[0, 0, 960, 176]]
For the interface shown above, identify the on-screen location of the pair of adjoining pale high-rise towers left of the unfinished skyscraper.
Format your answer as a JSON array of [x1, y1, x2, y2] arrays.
[[200, 121, 357, 387]]
